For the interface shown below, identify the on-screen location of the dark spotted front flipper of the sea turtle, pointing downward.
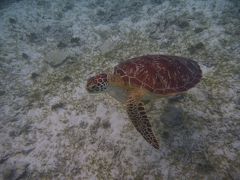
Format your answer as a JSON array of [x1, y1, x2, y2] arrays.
[[127, 96, 159, 149]]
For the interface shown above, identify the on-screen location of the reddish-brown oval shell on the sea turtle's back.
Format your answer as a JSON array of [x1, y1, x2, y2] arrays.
[[114, 55, 202, 95]]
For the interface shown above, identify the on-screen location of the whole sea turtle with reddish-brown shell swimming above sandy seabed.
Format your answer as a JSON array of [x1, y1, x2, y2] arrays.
[[86, 55, 202, 149]]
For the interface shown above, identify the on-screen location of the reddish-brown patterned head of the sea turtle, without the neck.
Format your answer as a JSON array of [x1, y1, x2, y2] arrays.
[[86, 73, 108, 93]]
